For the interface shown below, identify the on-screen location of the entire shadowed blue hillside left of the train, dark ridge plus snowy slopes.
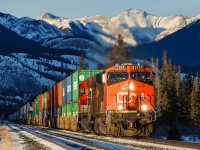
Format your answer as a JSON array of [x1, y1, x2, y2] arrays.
[[0, 19, 105, 113]]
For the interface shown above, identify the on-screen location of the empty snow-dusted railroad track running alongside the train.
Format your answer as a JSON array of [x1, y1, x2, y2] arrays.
[[8, 124, 136, 150]]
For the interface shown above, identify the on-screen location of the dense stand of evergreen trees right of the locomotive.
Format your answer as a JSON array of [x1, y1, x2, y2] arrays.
[[151, 50, 200, 136]]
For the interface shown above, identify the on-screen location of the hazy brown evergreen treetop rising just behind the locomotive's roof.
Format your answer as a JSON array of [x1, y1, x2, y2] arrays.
[[106, 34, 131, 67]]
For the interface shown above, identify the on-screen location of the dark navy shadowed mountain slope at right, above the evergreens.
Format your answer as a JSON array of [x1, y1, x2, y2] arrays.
[[132, 19, 200, 73]]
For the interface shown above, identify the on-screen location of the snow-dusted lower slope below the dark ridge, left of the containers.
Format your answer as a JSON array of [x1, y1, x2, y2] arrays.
[[0, 53, 83, 111]]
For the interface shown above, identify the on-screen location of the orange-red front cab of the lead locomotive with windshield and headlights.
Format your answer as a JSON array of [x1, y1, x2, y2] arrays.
[[104, 64, 154, 112]]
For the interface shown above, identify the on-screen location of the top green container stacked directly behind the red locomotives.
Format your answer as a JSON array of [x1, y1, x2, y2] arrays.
[[72, 70, 102, 102]]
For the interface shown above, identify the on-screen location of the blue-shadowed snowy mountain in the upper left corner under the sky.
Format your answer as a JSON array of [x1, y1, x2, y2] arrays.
[[0, 12, 64, 42]]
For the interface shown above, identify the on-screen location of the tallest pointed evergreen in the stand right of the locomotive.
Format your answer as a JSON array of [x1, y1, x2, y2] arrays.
[[160, 50, 177, 123]]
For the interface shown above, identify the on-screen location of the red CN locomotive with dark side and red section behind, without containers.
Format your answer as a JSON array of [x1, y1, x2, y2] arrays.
[[79, 64, 155, 136]]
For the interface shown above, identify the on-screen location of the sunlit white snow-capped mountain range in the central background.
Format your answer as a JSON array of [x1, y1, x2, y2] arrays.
[[38, 9, 198, 46]]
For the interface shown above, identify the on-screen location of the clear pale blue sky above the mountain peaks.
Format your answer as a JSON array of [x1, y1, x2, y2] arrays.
[[0, 0, 200, 18]]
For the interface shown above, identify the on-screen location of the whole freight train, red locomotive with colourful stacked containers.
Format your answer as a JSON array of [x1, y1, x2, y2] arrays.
[[9, 63, 156, 136]]
